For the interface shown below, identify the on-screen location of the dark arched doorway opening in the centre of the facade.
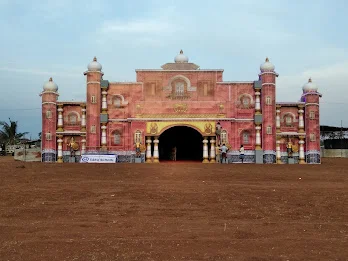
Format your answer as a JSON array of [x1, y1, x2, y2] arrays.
[[158, 126, 203, 161]]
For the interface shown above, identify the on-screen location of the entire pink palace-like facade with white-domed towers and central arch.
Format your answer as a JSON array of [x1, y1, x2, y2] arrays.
[[41, 51, 321, 164]]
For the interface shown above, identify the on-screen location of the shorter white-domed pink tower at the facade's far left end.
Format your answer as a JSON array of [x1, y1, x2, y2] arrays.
[[40, 78, 59, 162]]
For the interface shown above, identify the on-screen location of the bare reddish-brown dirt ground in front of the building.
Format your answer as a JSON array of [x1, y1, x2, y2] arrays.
[[0, 157, 348, 261]]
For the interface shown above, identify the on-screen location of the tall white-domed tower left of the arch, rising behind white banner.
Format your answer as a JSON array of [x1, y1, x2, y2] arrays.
[[84, 57, 103, 152]]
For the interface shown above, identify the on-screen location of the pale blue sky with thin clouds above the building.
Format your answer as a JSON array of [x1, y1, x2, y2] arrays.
[[0, 0, 348, 138]]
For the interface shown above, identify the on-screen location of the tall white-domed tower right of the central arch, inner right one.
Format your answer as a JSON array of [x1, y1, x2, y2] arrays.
[[259, 58, 278, 163]]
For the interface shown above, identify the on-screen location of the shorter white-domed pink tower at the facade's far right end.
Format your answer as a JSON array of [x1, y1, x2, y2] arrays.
[[301, 79, 322, 163]]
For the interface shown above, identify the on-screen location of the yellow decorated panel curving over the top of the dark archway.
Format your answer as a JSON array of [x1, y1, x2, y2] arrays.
[[146, 121, 215, 136]]
